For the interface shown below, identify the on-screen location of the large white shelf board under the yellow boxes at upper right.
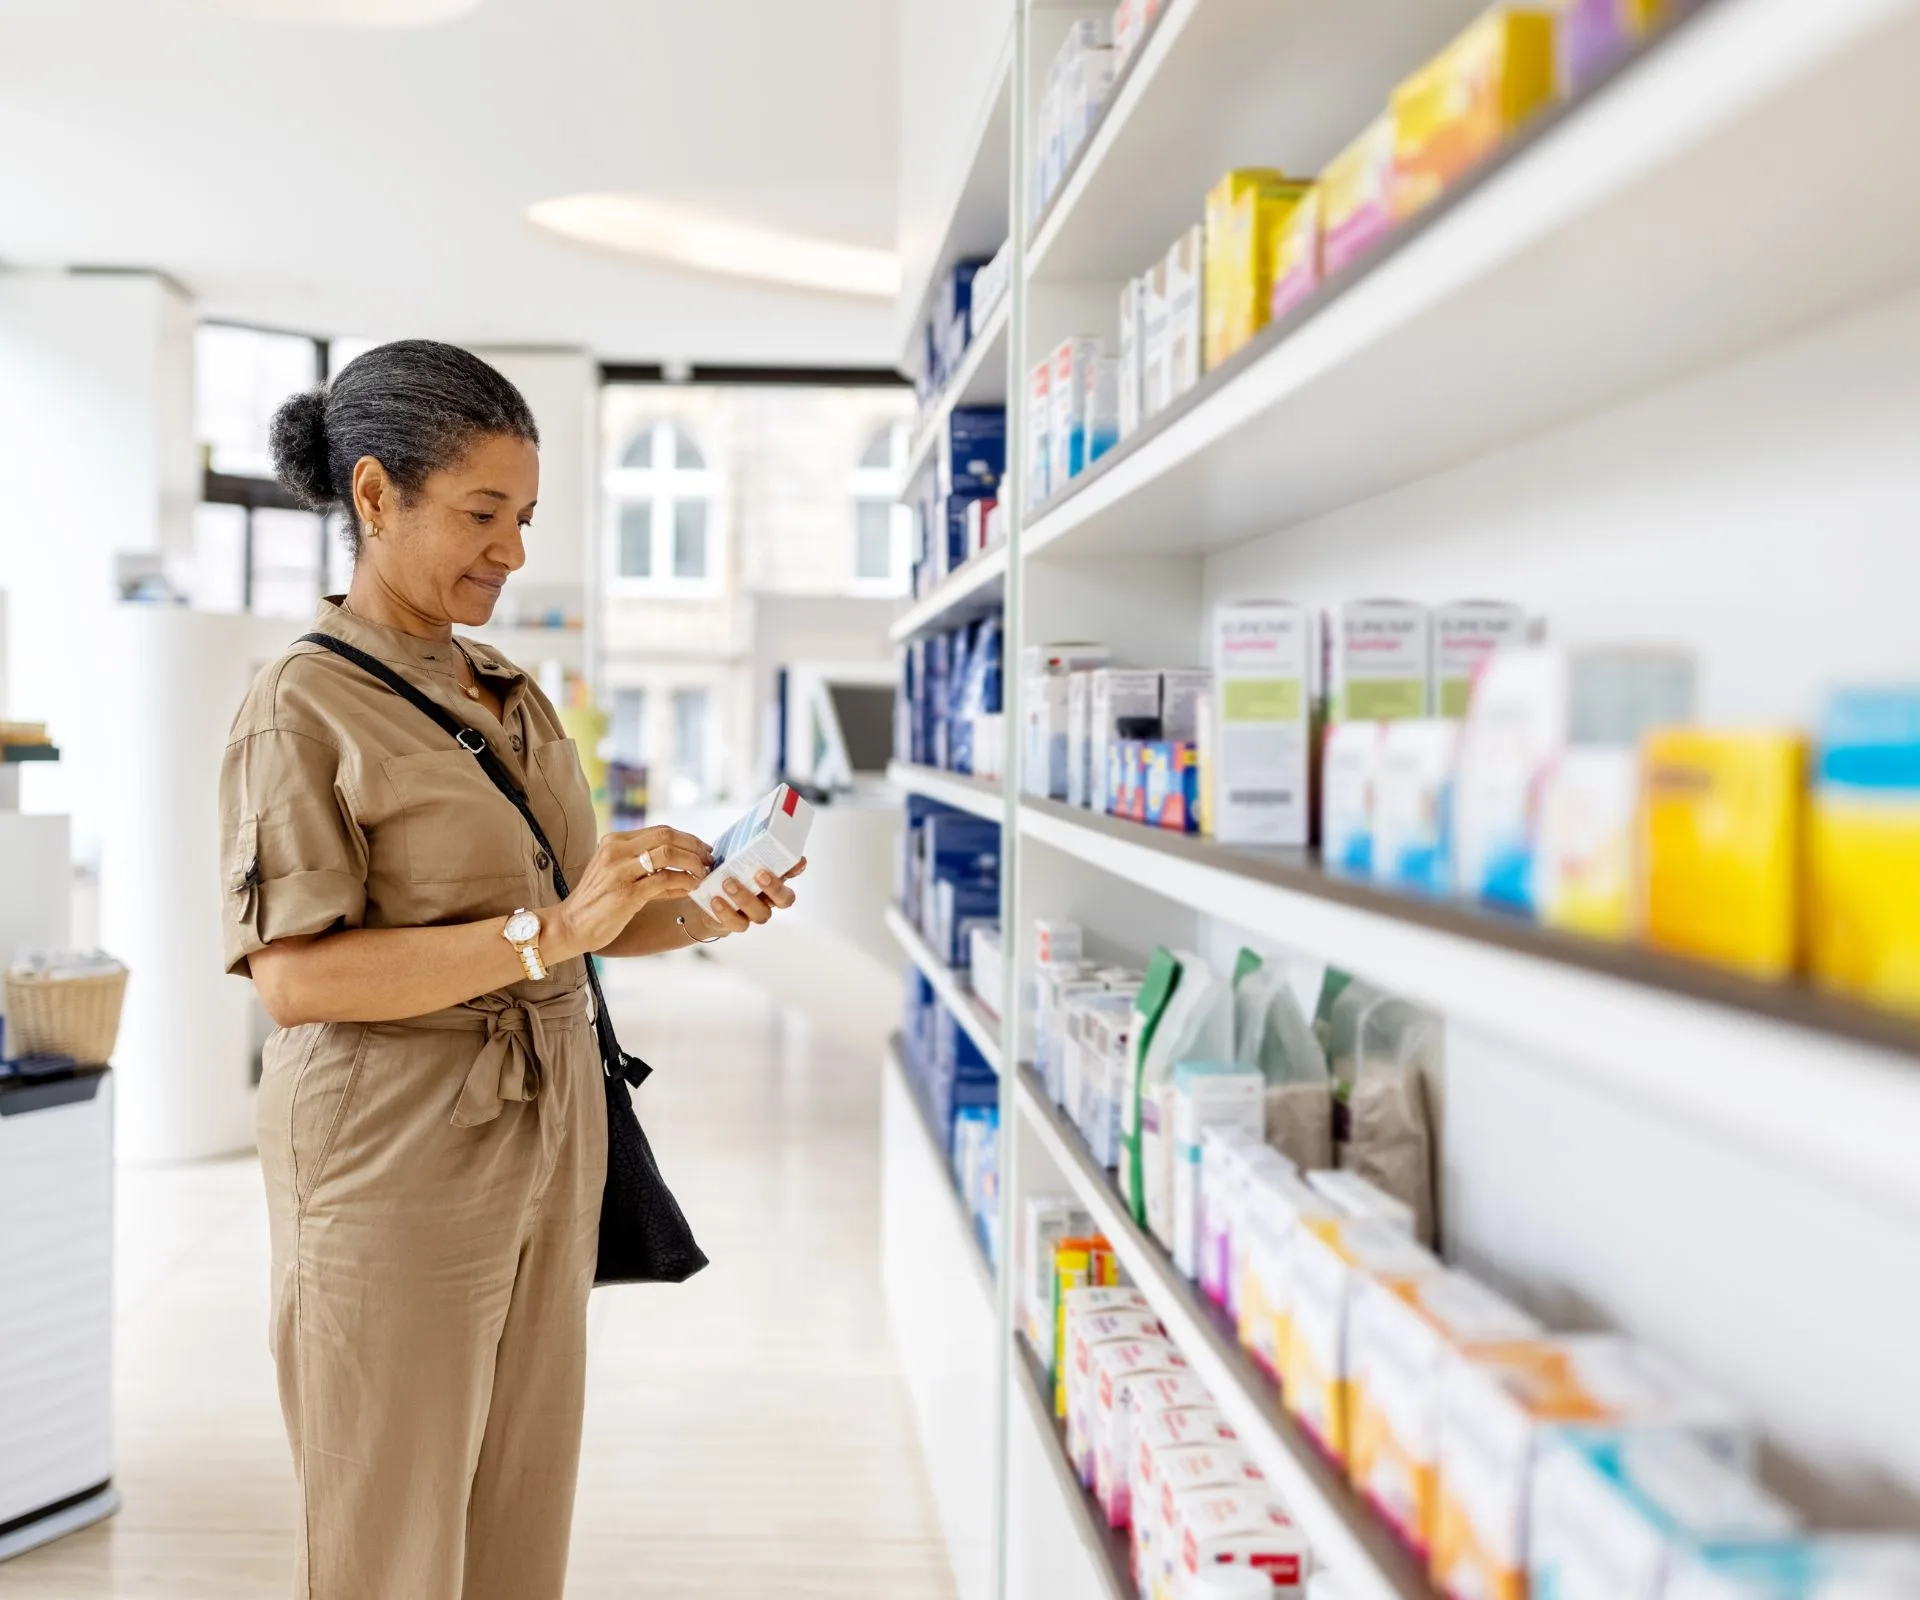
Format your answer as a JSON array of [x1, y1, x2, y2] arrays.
[[1023, 0, 1920, 555]]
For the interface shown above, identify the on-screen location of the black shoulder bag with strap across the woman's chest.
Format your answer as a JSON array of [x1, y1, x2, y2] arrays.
[[300, 634, 707, 1283]]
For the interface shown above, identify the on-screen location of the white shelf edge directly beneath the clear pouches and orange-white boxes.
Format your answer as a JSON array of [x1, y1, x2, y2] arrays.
[[1014, 1068, 1432, 1600]]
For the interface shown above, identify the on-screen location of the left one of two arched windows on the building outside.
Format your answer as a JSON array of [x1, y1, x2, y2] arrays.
[[607, 421, 720, 594]]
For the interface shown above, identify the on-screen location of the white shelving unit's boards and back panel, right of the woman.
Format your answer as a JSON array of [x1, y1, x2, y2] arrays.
[[891, 0, 1920, 1600]]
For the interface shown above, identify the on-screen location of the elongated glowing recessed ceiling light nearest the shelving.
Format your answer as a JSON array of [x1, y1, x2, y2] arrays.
[[526, 194, 900, 300]]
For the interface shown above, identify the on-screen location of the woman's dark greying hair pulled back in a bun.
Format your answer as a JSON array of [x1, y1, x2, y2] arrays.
[[271, 338, 540, 555]]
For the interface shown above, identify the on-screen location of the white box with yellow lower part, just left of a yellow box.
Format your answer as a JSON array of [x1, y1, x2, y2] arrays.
[[1534, 745, 1640, 939]]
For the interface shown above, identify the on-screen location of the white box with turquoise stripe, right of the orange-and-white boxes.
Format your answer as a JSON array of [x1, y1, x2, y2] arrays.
[[1526, 1431, 1797, 1600]]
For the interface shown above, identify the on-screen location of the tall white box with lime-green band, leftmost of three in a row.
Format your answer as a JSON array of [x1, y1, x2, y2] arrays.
[[1206, 599, 1319, 845]]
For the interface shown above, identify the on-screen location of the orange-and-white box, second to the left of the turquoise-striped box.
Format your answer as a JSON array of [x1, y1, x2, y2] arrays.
[[1348, 1272, 1546, 1556]]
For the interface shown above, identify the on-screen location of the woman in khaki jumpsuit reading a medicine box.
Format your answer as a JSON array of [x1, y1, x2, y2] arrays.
[[221, 340, 793, 1600]]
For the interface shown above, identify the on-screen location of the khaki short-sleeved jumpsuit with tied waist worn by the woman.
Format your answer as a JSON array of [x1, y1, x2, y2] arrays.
[[221, 601, 607, 1600]]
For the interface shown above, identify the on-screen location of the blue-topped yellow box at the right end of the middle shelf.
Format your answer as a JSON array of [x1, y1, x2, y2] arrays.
[[1807, 688, 1920, 1012]]
